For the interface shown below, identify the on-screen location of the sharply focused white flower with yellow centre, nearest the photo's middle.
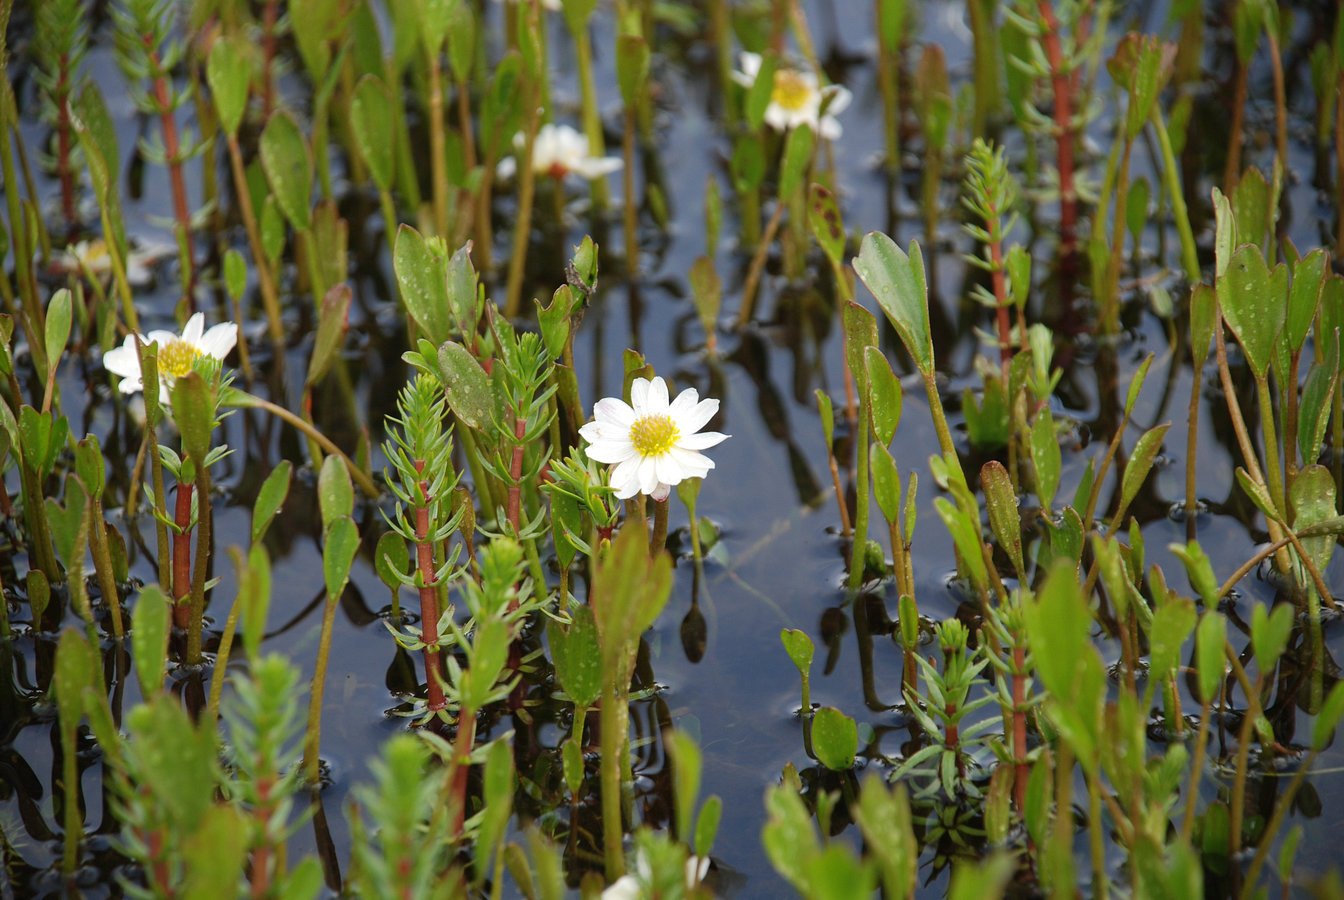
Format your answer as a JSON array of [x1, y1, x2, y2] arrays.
[[579, 377, 728, 500]]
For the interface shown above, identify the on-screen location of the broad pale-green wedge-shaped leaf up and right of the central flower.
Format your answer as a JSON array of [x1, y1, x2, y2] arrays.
[[853, 231, 934, 377]]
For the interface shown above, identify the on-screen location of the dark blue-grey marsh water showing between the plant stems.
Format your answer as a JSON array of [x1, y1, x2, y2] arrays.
[[0, 0, 1344, 897]]
